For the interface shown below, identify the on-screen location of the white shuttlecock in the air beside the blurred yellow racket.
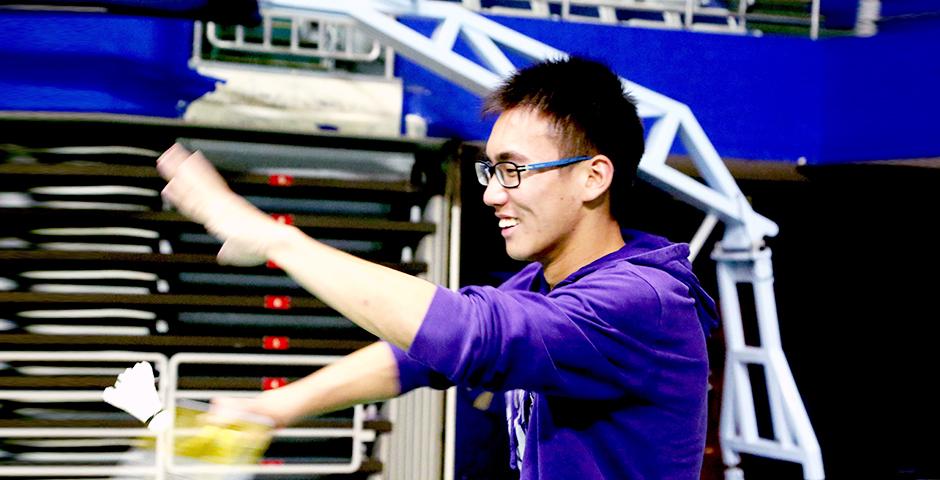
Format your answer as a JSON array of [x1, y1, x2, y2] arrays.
[[101, 362, 170, 432]]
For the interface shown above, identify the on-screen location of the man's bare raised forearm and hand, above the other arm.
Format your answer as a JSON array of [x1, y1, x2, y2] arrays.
[[157, 145, 437, 350]]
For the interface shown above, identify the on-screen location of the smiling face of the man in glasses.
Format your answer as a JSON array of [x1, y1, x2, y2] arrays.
[[483, 108, 581, 263]]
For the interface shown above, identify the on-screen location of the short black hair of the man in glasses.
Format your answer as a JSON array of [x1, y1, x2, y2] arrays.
[[483, 57, 644, 222]]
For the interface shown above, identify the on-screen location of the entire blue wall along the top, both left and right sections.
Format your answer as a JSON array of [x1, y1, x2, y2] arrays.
[[0, 12, 940, 163]]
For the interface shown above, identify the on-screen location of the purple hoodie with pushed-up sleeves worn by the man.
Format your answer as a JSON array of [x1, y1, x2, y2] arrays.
[[393, 230, 717, 480]]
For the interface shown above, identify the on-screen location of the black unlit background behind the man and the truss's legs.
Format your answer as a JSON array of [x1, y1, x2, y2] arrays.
[[458, 156, 940, 479]]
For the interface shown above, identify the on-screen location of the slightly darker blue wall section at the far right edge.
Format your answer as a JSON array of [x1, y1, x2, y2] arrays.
[[819, 19, 940, 162]]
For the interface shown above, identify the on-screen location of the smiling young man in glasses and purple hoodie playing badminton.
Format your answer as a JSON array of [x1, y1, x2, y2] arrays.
[[158, 59, 715, 480]]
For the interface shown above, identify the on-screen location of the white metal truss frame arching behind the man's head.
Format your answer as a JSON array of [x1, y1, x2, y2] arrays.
[[253, 0, 825, 480]]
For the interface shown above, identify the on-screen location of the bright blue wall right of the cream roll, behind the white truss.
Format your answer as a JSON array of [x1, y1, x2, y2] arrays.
[[398, 17, 940, 163]]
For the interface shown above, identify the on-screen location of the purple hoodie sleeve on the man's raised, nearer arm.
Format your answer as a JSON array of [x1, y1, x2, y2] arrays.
[[408, 266, 707, 400]]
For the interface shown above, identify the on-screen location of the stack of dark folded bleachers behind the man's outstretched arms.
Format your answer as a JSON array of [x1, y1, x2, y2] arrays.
[[0, 113, 452, 478]]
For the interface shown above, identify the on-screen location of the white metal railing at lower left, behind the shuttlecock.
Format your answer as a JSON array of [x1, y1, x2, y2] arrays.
[[0, 351, 375, 480]]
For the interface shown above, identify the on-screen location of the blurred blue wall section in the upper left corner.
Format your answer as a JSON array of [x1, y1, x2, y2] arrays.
[[0, 11, 215, 117]]
